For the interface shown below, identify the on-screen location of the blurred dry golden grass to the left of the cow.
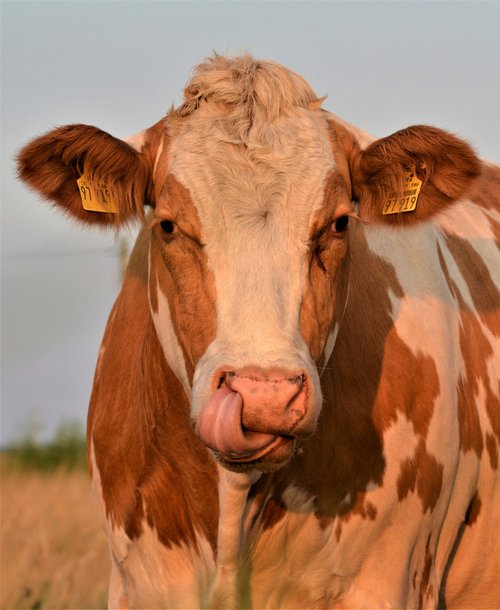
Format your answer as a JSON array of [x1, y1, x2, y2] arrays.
[[0, 468, 109, 609]]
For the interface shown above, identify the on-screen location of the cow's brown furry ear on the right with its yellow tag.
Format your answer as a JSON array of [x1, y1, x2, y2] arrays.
[[351, 125, 480, 225]]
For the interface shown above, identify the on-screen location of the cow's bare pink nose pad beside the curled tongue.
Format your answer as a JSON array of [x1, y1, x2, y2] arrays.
[[224, 368, 306, 435]]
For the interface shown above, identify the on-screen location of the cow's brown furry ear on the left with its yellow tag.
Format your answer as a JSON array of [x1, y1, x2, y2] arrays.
[[17, 125, 151, 226]]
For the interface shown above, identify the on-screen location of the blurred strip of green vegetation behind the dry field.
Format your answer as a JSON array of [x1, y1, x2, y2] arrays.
[[2, 422, 86, 472]]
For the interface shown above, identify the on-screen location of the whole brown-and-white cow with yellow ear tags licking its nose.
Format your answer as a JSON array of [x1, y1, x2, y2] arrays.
[[18, 55, 500, 609]]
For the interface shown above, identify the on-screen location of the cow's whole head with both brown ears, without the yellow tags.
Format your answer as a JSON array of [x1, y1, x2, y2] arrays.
[[19, 56, 478, 470]]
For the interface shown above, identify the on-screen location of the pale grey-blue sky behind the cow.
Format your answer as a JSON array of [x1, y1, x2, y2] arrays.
[[1, 0, 500, 444]]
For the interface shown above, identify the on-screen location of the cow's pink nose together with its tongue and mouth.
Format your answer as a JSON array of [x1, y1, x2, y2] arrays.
[[195, 368, 312, 470]]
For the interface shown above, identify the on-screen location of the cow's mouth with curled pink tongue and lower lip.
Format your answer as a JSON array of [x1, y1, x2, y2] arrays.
[[195, 385, 295, 470]]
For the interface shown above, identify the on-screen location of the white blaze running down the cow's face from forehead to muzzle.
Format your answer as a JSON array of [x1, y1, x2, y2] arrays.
[[170, 106, 334, 415]]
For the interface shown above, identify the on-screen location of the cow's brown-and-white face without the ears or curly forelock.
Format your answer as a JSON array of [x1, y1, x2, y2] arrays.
[[150, 98, 353, 466]]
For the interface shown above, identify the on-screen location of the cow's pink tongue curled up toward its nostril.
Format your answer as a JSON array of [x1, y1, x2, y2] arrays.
[[196, 386, 276, 460]]
